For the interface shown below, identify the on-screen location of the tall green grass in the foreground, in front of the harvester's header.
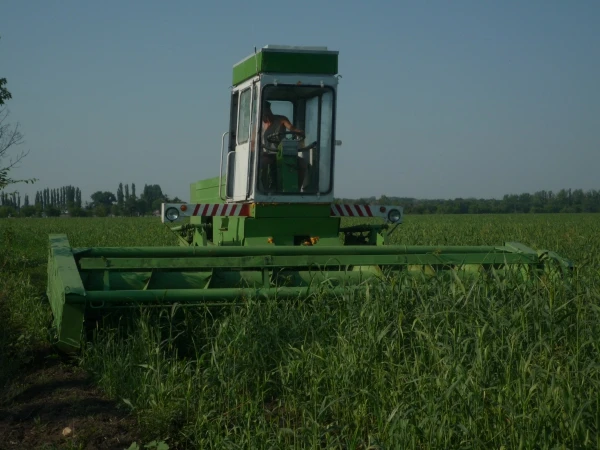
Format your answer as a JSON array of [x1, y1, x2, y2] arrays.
[[83, 272, 600, 448]]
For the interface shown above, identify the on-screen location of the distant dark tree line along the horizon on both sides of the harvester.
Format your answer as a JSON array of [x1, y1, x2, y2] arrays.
[[0, 183, 600, 218]]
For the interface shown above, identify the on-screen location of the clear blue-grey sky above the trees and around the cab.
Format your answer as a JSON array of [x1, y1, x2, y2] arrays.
[[0, 0, 600, 200]]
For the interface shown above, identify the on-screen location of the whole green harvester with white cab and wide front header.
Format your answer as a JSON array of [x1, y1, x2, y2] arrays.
[[47, 45, 572, 351]]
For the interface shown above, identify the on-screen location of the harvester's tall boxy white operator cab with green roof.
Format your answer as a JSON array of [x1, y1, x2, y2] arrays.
[[220, 46, 338, 203]]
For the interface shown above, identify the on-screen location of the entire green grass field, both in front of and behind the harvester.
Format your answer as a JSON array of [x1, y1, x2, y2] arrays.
[[0, 214, 600, 449]]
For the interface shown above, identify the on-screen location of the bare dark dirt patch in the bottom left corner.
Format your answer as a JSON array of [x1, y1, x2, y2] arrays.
[[0, 348, 140, 450]]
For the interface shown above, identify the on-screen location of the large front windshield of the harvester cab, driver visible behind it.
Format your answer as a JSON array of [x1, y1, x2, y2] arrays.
[[257, 85, 334, 194]]
